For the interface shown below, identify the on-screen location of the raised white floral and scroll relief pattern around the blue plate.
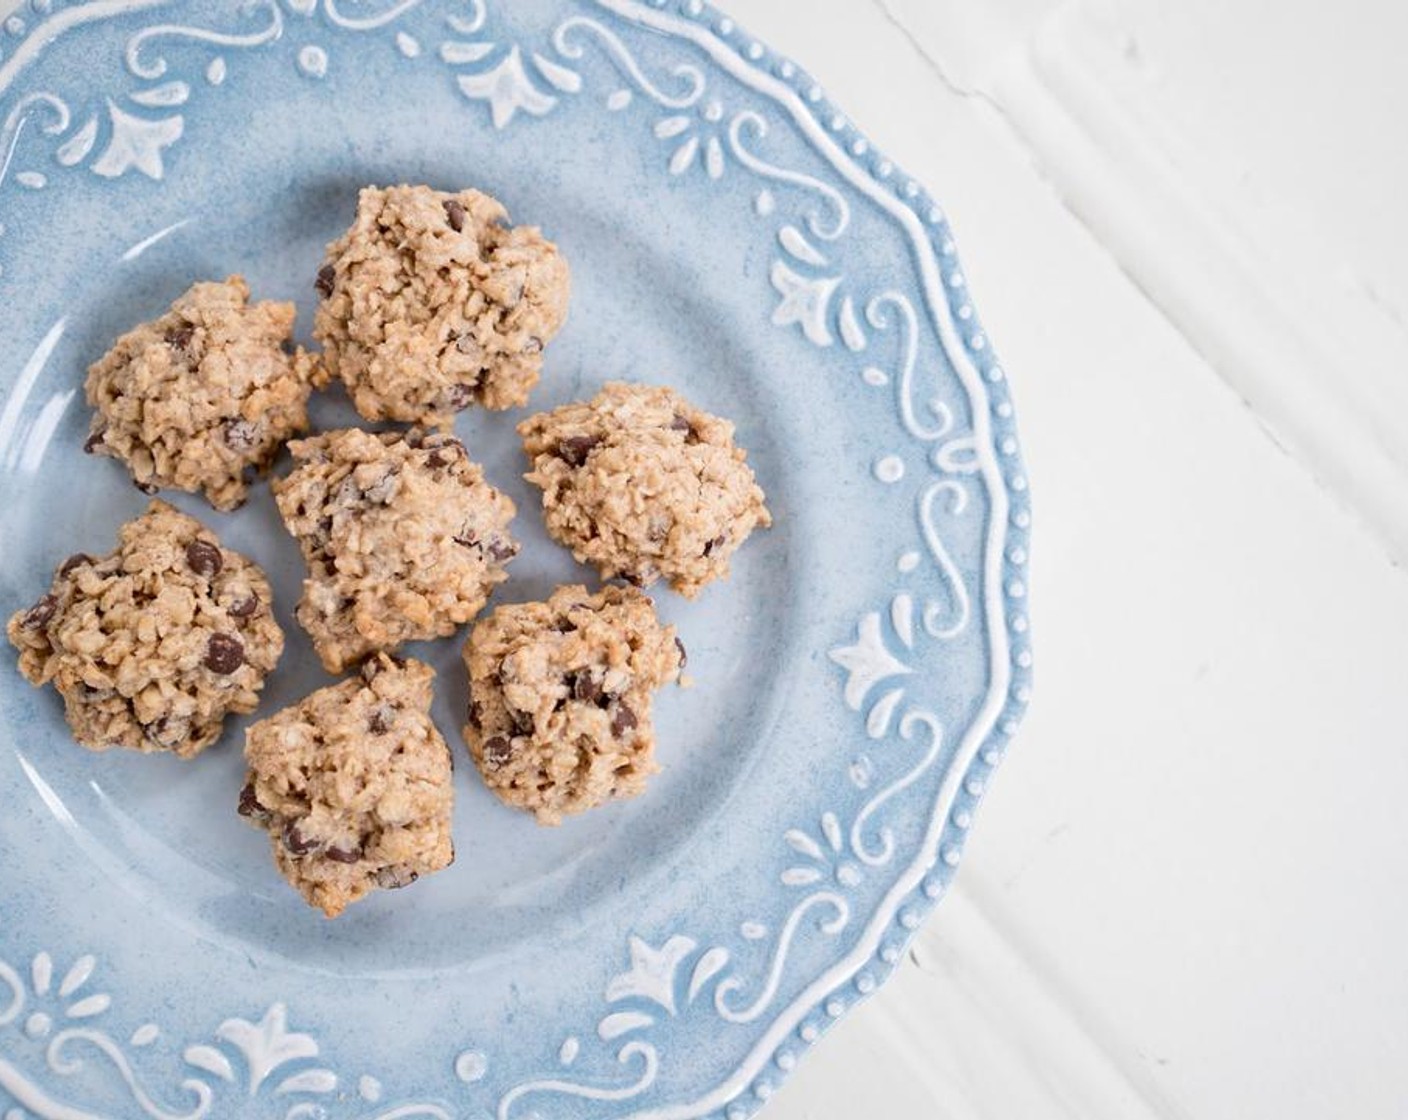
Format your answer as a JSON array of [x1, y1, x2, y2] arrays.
[[0, 0, 1029, 1120]]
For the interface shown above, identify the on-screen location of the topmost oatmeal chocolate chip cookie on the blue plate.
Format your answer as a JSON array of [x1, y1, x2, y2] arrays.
[[314, 186, 570, 427]]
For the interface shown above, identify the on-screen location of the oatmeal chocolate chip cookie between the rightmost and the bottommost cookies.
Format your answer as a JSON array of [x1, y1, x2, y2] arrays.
[[465, 586, 684, 824]]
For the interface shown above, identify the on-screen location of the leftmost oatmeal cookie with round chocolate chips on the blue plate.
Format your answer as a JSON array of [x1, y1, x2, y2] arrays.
[[7, 502, 283, 758]]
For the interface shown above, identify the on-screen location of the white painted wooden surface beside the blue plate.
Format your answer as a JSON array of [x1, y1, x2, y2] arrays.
[[731, 0, 1408, 1120]]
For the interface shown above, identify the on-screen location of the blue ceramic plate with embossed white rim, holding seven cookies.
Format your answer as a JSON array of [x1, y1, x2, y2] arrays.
[[0, 0, 1031, 1120]]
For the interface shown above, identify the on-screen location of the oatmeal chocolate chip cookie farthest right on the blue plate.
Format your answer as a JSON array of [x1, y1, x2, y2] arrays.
[[518, 382, 772, 599]]
